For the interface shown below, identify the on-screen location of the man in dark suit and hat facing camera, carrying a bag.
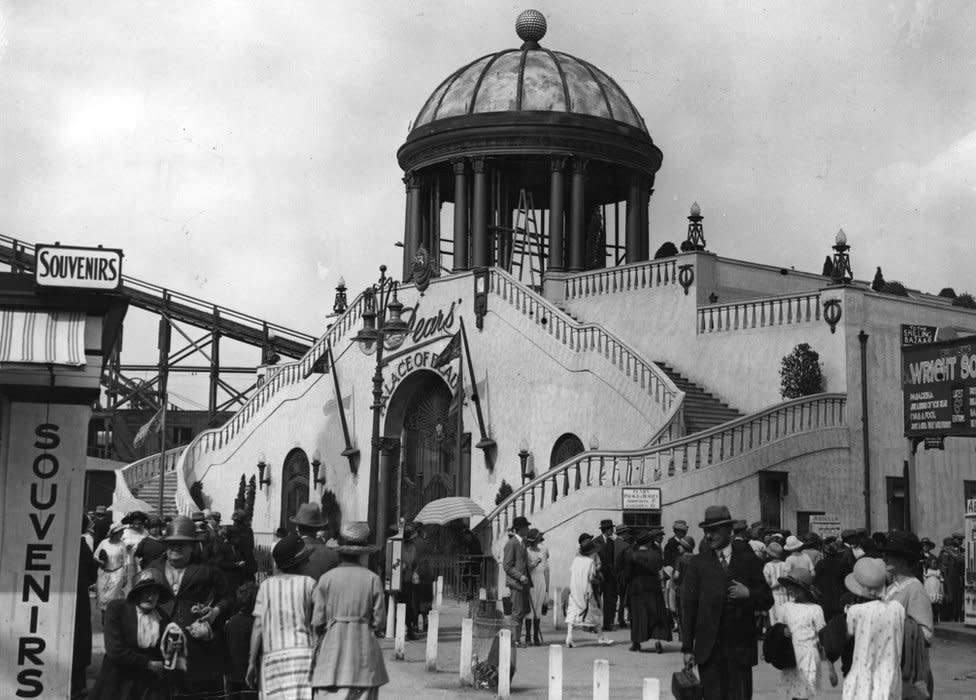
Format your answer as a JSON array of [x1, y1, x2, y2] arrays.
[[681, 506, 773, 700]]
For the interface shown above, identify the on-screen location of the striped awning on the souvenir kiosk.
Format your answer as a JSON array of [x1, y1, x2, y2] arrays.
[[0, 310, 86, 367]]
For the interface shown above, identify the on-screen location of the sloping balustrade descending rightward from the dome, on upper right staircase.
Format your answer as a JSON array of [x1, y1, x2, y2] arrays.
[[490, 268, 684, 418]]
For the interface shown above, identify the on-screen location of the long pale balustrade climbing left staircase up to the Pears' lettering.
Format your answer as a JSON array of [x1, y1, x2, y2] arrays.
[[176, 294, 363, 514]]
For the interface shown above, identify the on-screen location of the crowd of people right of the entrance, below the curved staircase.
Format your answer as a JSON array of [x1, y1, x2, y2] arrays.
[[503, 506, 964, 700]]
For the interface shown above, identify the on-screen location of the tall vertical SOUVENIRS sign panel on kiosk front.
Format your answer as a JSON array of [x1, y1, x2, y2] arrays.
[[0, 403, 90, 698]]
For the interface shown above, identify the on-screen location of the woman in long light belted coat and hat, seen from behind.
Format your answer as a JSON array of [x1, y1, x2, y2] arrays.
[[310, 522, 389, 700]]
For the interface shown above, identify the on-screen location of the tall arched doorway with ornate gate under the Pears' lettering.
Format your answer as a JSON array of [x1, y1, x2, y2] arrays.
[[381, 370, 471, 525]]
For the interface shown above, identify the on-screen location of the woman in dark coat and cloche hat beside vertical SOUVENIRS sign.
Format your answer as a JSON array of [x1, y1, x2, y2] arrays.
[[91, 569, 173, 700]]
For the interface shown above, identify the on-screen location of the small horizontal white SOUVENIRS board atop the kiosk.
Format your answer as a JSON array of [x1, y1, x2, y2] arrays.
[[34, 245, 122, 291]]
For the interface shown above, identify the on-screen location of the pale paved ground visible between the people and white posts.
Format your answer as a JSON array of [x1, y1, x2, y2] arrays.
[[89, 603, 976, 700]]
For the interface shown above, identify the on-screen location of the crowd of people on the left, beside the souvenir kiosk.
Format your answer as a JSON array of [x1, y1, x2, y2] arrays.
[[73, 503, 388, 700]]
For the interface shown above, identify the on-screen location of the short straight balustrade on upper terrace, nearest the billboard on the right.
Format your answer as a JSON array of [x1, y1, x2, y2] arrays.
[[697, 292, 821, 335]]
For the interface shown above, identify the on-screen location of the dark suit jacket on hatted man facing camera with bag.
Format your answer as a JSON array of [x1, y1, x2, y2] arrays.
[[681, 548, 773, 666]]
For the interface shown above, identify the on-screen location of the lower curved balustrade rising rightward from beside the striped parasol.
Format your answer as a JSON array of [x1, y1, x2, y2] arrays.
[[483, 394, 847, 540]]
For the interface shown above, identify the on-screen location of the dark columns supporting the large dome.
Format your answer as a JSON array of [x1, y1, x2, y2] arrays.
[[403, 157, 653, 279]]
